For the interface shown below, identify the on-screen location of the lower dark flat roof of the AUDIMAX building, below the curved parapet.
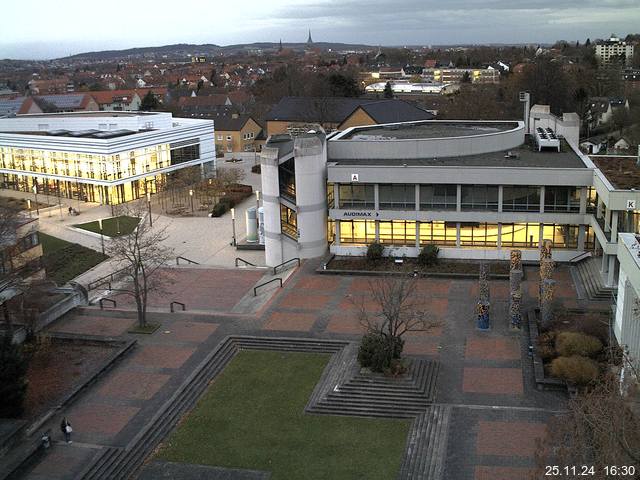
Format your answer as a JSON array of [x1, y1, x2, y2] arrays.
[[328, 138, 587, 168]]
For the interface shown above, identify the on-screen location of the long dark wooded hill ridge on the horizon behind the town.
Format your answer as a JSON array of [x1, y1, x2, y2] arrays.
[[57, 42, 374, 61]]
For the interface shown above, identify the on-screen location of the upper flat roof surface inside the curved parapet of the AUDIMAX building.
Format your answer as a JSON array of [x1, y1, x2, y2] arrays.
[[334, 120, 518, 141]]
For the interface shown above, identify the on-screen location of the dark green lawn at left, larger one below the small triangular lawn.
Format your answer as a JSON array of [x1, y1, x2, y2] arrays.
[[38, 232, 109, 285]]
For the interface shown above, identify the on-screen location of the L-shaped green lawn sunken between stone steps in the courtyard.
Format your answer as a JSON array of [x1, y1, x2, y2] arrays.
[[158, 351, 410, 480]]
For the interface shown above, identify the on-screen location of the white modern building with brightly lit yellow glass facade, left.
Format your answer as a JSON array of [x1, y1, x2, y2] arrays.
[[0, 112, 216, 204]]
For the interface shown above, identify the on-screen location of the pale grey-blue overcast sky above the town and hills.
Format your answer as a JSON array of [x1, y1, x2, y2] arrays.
[[0, 0, 640, 59]]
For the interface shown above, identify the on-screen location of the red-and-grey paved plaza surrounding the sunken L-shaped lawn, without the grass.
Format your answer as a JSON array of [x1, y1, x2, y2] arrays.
[[12, 261, 608, 480]]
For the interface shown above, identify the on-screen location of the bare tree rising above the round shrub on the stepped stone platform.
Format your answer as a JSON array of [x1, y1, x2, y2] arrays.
[[356, 276, 439, 365]]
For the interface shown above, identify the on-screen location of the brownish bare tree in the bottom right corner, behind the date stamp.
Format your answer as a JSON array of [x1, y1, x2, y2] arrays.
[[536, 356, 640, 480]]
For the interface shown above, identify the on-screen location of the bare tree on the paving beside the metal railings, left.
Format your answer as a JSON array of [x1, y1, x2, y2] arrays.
[[106, 205, 173, 328]]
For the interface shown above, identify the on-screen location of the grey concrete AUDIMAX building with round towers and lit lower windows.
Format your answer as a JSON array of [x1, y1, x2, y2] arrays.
[[261, 113, 611, 265]]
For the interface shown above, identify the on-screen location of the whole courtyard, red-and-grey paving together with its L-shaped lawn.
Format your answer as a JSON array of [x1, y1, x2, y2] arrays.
[[11, 261, 602, 480]]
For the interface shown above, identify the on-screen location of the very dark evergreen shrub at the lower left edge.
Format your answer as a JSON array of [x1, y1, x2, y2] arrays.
[[0, 336, 28, 418]]
